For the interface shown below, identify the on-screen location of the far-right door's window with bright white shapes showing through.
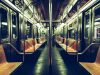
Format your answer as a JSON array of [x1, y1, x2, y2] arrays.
[[94, 8, 100, 39]]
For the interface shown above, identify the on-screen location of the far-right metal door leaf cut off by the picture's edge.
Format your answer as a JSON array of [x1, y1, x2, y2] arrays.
[[91, 3, 100, 62]]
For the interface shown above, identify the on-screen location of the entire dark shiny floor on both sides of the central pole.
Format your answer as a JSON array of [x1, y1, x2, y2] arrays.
[[13, 42, 87, 75]]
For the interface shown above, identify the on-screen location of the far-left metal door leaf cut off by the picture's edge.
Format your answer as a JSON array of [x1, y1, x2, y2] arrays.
[[0, 3, 11, 62]]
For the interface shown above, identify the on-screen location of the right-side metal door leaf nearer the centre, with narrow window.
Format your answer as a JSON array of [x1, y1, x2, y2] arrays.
[[83, 9, 92, 62]]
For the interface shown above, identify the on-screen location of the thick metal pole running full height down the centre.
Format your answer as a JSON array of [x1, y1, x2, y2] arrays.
[[49, 0, 52, 75]]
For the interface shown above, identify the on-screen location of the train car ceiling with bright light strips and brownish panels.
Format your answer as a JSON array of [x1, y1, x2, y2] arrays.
[[1, 0, 95, 28]]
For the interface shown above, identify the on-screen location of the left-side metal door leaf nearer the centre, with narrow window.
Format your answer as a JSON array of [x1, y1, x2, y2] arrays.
[[10, 10, 19, 62]]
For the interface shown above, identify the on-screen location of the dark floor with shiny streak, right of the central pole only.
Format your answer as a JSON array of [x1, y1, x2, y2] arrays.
[[52, 46, 87, 75]]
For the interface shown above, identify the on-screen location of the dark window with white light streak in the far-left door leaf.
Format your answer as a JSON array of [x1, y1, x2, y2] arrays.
[[0, 8, 8, 39]]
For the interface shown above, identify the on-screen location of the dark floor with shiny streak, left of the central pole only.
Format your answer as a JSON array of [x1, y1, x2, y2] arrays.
[[13, 45, 49, 75]]
